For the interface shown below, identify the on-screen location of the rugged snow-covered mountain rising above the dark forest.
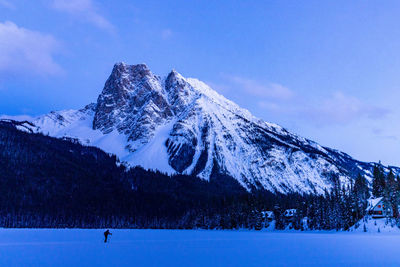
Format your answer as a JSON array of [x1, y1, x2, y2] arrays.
[[7, 63, 400, 193]]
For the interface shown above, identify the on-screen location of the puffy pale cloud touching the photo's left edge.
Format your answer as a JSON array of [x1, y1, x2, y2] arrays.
[[0, 21, 62, 75]]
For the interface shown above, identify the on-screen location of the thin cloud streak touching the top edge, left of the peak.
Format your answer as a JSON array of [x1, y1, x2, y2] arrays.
[[52, 0, 114, 32]]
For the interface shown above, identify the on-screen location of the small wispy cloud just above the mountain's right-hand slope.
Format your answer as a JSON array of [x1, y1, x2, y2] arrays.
[[227, 76, 294, 100]]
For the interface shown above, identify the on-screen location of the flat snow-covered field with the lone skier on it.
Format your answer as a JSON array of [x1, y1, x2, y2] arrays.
[[0, 229, 400, 267]]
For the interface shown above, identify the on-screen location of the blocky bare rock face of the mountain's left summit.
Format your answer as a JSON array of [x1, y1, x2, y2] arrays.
[[93, 63, 173, 151]]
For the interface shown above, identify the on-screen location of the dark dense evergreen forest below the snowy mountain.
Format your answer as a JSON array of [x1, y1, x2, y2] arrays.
[[0, 121, 400, 230]]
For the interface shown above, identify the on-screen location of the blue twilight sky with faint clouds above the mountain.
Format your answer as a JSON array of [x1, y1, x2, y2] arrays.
[[0, 0, 400, 165]]
